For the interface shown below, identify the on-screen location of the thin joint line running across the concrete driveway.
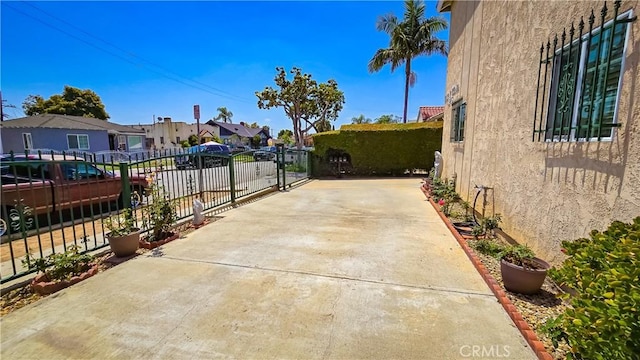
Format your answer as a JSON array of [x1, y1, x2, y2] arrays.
[[156, 256, 494, 298]]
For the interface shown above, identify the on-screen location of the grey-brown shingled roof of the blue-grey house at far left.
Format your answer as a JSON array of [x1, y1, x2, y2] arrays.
[[0, 114, 145, 134]]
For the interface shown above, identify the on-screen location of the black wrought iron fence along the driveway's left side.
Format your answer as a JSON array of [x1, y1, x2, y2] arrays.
[[0, 150, 308, 283]]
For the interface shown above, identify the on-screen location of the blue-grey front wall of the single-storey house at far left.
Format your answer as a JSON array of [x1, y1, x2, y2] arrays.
[[1, 128, 109, 153]]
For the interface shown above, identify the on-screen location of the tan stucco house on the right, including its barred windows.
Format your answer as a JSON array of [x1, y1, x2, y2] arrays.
[[437, 0, 640, 263]]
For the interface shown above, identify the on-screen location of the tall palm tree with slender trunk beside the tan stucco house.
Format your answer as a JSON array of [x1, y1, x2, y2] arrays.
[[369, 0, 447, 123]]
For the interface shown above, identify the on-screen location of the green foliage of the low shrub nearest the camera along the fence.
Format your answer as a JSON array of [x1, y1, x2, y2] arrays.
[[22, 245, 93, 281]]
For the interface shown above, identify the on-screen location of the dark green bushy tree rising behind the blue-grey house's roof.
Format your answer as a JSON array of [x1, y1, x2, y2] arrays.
[[22, 85, 109, 120]]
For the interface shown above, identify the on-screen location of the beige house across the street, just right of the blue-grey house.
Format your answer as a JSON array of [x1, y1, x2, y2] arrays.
[[131, 117, 220, 150]]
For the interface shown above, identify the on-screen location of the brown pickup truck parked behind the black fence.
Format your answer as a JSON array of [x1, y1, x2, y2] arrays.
[[0, 155, 148, 219]]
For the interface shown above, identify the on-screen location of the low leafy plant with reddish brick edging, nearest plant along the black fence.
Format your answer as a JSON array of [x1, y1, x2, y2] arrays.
[[22, 245, 98, 295]]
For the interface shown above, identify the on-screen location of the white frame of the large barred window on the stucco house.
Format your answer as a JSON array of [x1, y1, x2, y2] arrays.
[[545, 10, 633, 142]]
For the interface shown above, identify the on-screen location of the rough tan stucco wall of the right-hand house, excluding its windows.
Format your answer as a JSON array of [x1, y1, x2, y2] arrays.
[[442, 1, 640, 263]]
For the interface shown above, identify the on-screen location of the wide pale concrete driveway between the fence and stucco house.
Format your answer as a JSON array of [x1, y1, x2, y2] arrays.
[[1, 178, 535, 359]]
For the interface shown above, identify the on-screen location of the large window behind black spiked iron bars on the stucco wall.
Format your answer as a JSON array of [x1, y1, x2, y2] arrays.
[[533, 8, 632, 141]]
